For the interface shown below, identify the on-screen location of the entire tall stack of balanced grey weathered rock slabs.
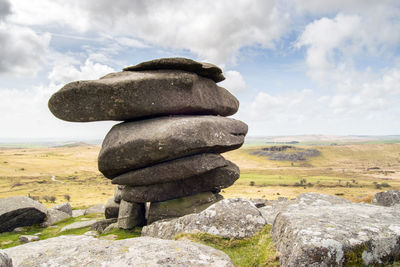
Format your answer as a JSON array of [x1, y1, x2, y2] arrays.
[[49, 58, 247, 229]]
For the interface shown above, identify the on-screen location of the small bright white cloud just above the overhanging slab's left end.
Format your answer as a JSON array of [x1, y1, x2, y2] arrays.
[[49, 59, 114, 84]]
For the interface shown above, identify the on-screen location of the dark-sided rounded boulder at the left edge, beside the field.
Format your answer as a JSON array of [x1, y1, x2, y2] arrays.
[[0, 196, 47, 233]]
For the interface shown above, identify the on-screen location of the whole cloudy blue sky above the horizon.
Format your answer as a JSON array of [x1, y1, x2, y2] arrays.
[[0, 0, 400, 140]]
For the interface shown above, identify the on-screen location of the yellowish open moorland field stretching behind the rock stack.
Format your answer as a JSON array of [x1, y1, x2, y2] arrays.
[[0, 143, 400, 207]]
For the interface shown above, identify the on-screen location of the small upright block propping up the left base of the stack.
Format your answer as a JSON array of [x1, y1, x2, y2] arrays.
[[118, 200, 146, 229]]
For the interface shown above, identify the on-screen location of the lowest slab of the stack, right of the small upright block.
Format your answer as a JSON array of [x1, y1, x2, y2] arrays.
[[147, 192, 223, 224]]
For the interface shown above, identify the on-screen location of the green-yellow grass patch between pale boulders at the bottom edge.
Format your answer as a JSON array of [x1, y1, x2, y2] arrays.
[[175, 225, 279, 267]]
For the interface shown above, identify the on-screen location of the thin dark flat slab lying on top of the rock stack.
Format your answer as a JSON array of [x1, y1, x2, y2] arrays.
[[124, 57, 225, 82]]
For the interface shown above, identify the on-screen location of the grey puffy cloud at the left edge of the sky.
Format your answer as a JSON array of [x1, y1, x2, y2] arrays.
[[0, 24, 50, 75]]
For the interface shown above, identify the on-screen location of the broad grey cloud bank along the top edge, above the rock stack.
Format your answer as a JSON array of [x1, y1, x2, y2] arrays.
[[8, 0, 289, 64]]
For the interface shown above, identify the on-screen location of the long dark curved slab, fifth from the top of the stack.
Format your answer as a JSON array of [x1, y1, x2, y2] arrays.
[[122, 161, 240, 203]]
